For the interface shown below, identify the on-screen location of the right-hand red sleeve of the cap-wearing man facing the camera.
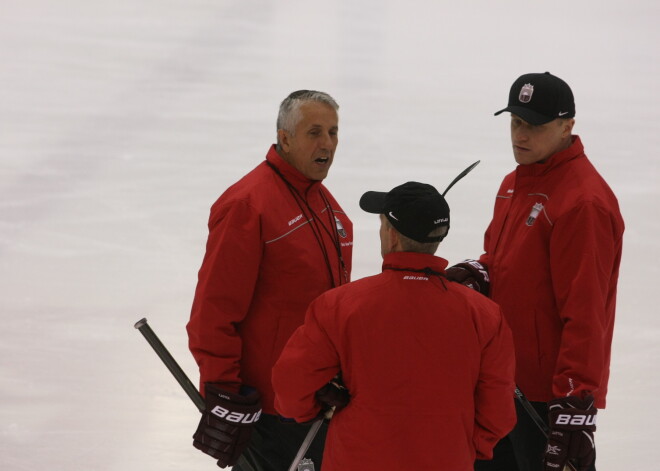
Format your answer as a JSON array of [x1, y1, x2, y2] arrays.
[[550, 203, 621, 397]]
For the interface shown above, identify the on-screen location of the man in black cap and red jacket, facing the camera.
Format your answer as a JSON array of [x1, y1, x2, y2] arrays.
[[447, 72, 624, 471]]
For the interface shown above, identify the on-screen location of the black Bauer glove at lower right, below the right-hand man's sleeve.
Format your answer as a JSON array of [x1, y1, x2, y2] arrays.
[[543, 396, 598, 471]]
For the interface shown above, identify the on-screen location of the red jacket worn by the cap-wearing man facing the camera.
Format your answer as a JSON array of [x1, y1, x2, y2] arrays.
[[481, 136, 624, 408]]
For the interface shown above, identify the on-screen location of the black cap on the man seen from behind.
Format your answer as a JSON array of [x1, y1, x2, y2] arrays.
[[360, 182, 449, 242]]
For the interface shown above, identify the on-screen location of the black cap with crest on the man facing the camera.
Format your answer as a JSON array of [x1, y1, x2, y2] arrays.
[[495, 72, 575, 125]]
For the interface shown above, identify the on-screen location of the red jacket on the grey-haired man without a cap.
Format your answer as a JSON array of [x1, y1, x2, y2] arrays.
[[187, 146, 353, 414]]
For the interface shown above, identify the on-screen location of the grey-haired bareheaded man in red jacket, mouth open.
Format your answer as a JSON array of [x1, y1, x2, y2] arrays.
[[187, 90, 353, 471]]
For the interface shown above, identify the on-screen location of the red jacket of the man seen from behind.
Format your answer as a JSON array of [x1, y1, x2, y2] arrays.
[[273, 252, 516, 471]]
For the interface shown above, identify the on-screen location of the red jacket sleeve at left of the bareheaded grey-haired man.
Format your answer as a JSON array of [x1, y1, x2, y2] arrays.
[[186, 198, 262, 391]]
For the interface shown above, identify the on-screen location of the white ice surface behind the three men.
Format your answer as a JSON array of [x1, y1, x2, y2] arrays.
[[0, 0, 660, 471]]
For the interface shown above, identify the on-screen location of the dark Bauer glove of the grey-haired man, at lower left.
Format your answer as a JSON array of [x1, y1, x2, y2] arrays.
[[193, 383, 261, 468]]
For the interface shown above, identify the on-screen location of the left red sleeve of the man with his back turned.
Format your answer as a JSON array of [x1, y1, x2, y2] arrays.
[[272, 295, 340, 422]]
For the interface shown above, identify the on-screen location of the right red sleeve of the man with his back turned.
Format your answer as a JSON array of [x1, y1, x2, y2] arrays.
[[473, 312, 516, 460]]
